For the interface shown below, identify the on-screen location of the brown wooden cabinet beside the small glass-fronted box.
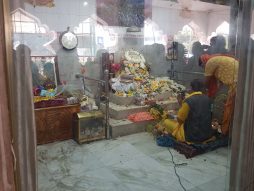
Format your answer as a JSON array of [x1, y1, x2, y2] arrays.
[[35, 105, 80, 144]]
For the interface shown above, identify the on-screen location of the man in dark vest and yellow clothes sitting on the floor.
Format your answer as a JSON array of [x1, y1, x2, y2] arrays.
[[155, 79, 215, 143]]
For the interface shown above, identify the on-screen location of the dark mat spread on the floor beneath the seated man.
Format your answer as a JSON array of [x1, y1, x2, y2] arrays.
[[156, 135, 229, 158]]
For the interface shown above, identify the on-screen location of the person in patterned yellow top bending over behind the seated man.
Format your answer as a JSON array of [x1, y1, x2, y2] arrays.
[[199, 54, 239, 135]]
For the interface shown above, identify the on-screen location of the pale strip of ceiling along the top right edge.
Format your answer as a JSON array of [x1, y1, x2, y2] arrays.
[[153, 0, 230, 12]]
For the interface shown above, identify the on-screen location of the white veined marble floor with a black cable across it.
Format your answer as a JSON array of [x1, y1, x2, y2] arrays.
[[37, 133, 229, 191]]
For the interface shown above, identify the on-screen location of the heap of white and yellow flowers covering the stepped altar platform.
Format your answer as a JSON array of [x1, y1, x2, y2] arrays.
[[110, 50, 185, 105]]
